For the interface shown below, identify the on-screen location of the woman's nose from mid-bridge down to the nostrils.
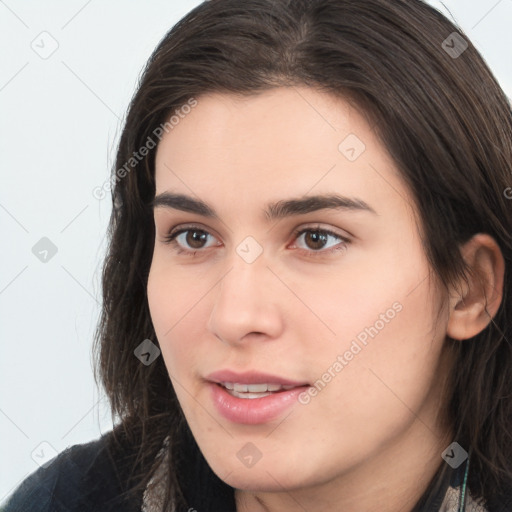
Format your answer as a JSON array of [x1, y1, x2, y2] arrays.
[[207, 250, 286, 345]]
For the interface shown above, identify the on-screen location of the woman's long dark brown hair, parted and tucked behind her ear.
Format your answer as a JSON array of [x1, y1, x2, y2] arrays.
[[94, 0, 512, 508]]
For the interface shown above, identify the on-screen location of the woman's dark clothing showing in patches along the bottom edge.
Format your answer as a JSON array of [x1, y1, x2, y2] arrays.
[[1, 432, 512, 512]]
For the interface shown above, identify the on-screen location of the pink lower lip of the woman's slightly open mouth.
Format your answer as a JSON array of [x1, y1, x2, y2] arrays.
[[208, 382, 309, 425]]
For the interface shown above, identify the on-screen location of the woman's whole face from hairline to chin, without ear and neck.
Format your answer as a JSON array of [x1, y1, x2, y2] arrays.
[[148, 87, 447, 491]]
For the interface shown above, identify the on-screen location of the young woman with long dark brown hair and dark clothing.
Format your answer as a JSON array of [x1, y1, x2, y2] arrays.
[[6, 0, 512, 512]]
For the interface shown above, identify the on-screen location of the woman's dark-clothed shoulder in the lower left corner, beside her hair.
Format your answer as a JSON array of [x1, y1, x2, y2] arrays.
[[1, 432, 140, 512]]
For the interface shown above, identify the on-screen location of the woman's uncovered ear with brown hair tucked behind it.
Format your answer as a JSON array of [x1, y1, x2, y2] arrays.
[[446, 233, 505, 340]]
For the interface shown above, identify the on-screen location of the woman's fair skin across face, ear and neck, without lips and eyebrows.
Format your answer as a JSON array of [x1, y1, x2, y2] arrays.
[[147, 87, 503, 512]]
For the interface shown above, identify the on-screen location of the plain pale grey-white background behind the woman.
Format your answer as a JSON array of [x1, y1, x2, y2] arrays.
[[0, 0, 512, 503]]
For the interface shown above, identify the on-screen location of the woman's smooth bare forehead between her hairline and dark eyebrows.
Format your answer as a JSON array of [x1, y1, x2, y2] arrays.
[[156, 87, 410, 219]]
